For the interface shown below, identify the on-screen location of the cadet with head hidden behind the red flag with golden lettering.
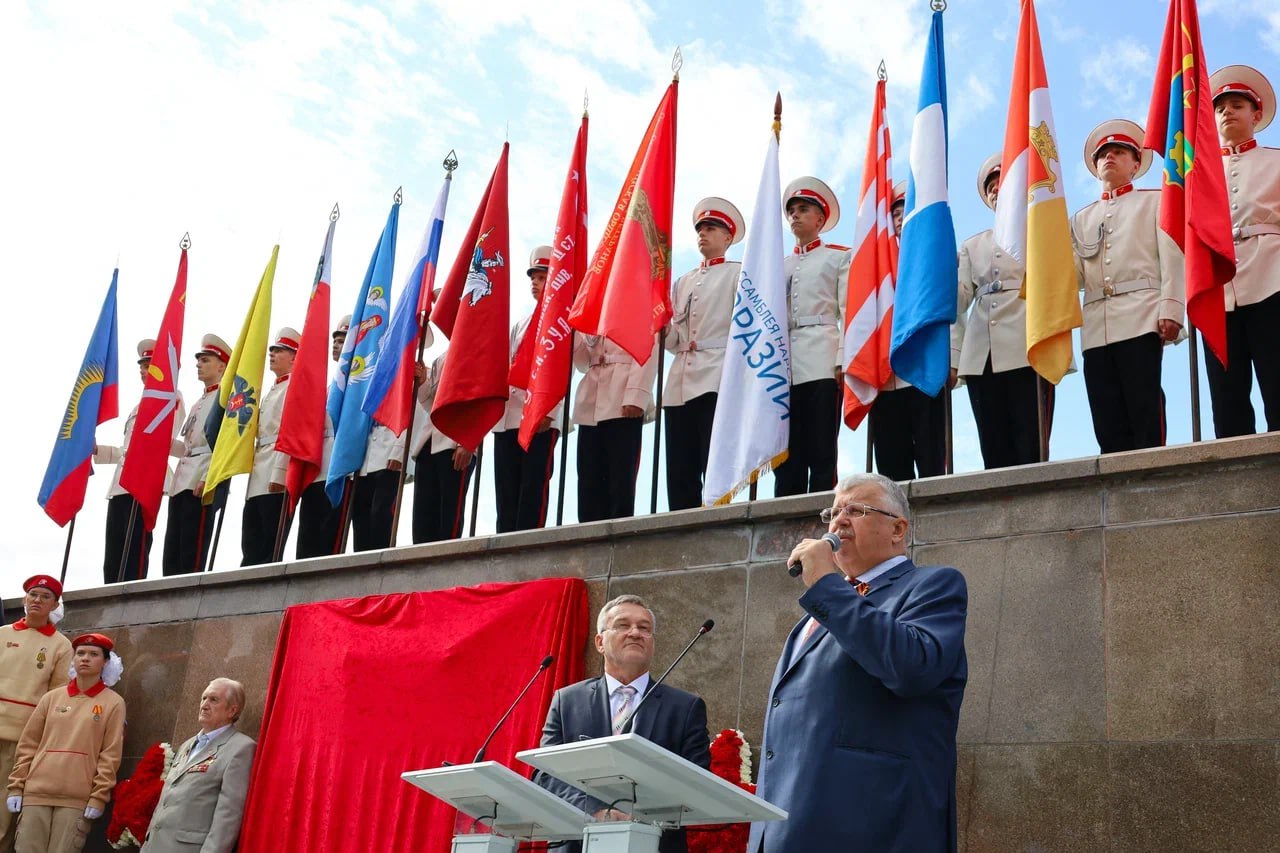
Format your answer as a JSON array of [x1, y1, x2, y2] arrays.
[[572, 334, 658, 521]]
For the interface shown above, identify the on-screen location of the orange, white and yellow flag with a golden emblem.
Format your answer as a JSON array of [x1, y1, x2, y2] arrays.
[[995, 0, 1080, 384]]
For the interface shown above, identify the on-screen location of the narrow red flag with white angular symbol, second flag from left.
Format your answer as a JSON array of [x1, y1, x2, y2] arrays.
[[120, 241, 187, 530]]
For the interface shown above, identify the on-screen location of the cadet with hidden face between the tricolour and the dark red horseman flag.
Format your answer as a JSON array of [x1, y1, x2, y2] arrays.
[[410, 348, 476, 544]]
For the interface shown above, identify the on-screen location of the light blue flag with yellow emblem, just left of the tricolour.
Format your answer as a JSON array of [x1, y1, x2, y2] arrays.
[[325, 200, 399, 506]]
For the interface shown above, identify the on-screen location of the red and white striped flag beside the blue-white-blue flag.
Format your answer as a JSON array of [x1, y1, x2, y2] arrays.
[[844, 81, 897, 429]]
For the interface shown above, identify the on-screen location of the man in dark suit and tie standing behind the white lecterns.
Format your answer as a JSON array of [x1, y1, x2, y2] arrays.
[[534, 596, 712, 853]]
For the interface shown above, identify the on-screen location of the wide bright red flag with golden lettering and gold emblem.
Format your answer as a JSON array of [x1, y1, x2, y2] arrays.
[[568, 79, 678, 364]]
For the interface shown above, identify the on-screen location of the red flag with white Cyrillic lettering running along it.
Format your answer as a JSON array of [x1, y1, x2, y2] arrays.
[[509, 115, 586, 451]]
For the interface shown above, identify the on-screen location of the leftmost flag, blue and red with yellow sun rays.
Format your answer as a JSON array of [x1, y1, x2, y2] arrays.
[[38, 269, 120, 526]]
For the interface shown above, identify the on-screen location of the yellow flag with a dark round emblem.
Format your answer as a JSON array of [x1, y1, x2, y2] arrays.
[[204, 246, 280, 503]]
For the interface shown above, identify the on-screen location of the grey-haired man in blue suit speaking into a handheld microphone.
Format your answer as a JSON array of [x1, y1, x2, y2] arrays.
[[746, 474, 968, 853]]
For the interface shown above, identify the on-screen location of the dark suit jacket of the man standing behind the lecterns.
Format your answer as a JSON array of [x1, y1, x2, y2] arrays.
[[534, 675, 712, 853]]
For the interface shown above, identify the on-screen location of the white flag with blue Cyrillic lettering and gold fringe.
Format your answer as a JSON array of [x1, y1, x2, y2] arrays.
[[703, 133, 791, 506]]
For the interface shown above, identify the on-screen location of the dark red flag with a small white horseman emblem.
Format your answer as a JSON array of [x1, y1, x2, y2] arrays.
[[431, 142, 511, 451]]
